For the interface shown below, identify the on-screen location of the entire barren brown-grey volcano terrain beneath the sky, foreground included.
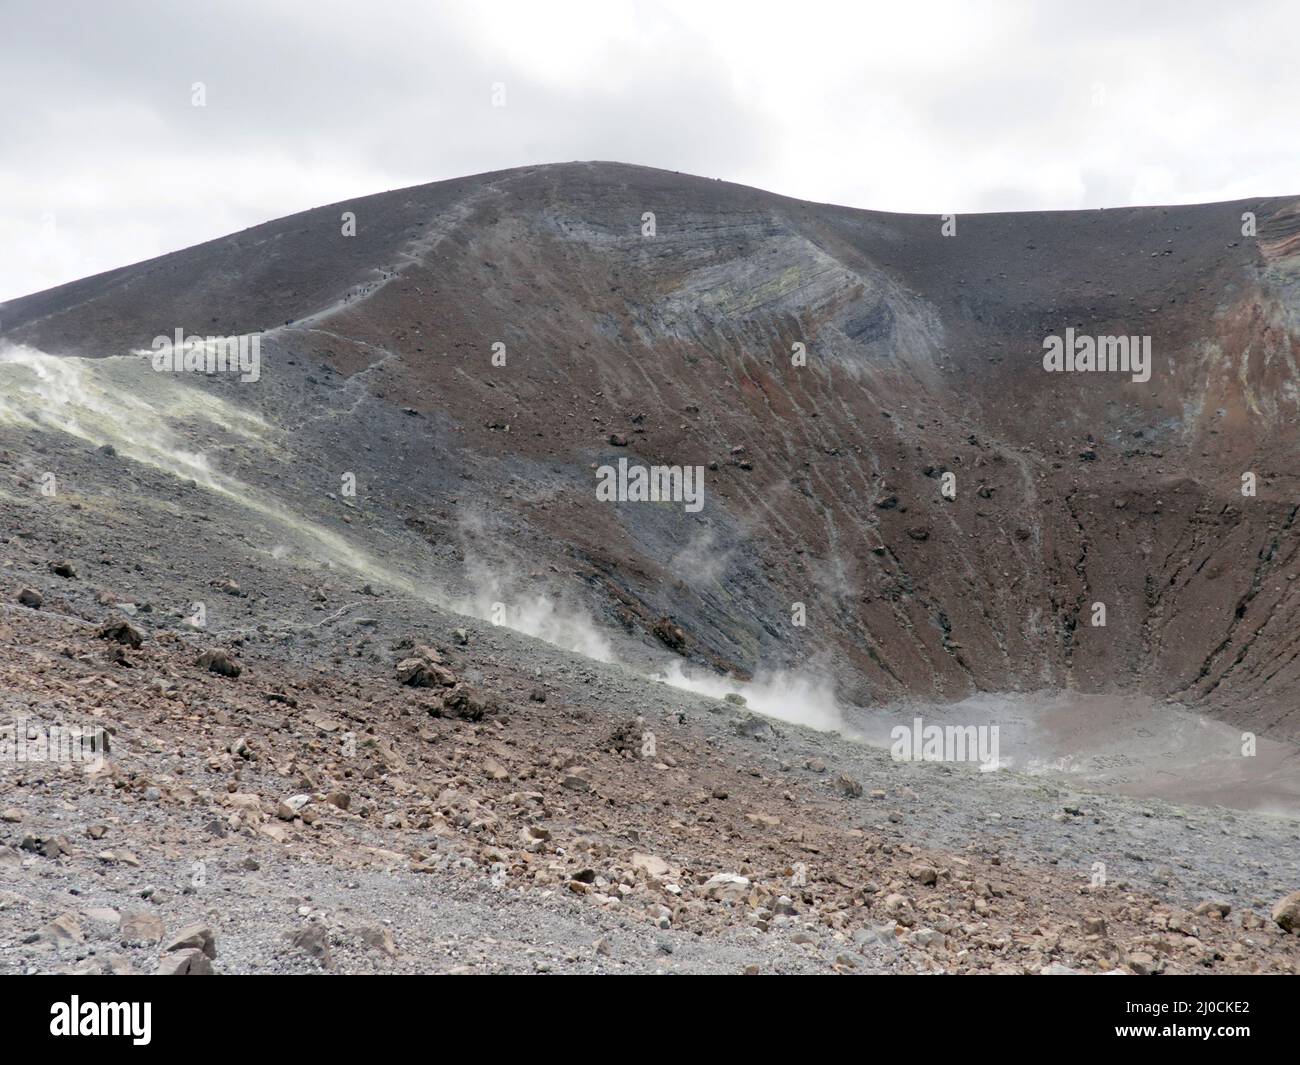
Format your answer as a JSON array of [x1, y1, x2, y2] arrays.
[[0, 164, 1300, 973]]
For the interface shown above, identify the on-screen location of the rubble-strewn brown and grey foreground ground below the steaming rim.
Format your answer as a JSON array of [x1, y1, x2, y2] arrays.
[[0, 587, 1300, 974]]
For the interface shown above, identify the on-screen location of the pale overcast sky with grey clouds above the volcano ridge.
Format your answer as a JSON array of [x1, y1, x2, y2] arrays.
[[0, 0, 1300, 299]]
